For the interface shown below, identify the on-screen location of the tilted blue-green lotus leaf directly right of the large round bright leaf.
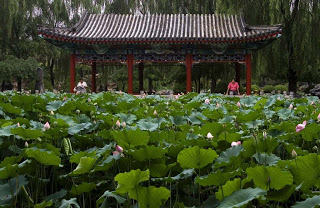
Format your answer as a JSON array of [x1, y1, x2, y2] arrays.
[[214, 145, 244, 168]]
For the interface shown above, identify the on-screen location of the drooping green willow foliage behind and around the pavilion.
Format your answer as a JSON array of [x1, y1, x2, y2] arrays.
[[0, 0, 320, 92]]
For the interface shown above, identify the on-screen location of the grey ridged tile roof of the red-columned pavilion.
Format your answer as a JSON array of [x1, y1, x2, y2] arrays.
[[38, 13, 282, 43]]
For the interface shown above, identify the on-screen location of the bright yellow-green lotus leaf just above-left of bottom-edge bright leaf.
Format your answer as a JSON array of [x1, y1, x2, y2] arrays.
[[114, 169, 149, 193]]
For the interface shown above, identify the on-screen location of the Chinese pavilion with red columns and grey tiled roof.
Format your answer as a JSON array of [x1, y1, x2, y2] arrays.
[[38, 12, 282, 94]]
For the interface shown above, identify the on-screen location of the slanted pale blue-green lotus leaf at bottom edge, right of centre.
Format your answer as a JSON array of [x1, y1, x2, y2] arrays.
[[218, 188, 267, 208]]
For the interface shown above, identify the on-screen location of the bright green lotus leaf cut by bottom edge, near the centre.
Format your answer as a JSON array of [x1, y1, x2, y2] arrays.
[[129, 186, 170, 208]]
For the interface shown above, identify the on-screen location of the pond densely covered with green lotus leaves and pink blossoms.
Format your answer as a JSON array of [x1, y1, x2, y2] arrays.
[[0, 93, 320, 208]]
